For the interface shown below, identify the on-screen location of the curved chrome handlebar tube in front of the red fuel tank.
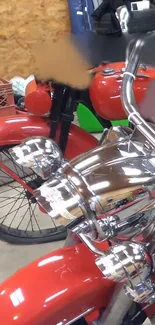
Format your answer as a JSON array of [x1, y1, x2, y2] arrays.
[[121, 32, 155, 147]]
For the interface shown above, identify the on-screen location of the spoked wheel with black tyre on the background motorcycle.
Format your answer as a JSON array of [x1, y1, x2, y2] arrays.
[[0, 147, 67, 244]]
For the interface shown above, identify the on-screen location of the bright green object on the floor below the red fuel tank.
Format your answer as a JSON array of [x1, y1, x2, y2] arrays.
[[77, 104, 129, 133]]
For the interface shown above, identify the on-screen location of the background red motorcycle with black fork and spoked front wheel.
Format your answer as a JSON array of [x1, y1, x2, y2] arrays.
[[0, 31, 155, 243]]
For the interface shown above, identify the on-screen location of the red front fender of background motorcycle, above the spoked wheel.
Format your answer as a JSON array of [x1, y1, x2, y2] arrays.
[[0, 114, 98, 160]]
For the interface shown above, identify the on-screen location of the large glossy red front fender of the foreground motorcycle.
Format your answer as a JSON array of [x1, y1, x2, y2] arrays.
[[0, 244, 114, 325]]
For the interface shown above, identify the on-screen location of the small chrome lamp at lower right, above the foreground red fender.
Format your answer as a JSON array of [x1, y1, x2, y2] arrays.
[[95, 242, 155, 303]]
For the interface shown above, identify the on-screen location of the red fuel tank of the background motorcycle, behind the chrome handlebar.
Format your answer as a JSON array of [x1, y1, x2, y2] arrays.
[[90, 62, 155, 120]]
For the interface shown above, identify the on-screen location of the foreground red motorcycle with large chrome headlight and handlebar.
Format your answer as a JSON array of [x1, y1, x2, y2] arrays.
[[0, 20, 155, 325]]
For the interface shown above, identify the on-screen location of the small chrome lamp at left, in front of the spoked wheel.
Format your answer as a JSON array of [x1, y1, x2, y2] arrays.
[[9, 137, 63, 180]]
